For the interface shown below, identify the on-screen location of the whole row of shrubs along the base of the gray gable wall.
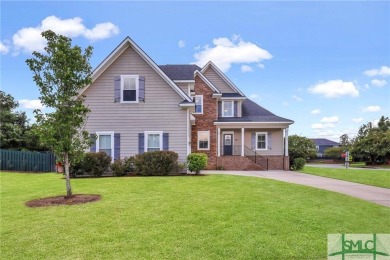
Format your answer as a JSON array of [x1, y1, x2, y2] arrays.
[[70, 151, 207, 177]]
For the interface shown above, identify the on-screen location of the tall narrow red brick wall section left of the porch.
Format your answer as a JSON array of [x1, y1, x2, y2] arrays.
[[191, 76, 218, 169]]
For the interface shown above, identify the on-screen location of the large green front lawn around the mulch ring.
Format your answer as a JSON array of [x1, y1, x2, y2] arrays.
[[0, 173, 390, 259]]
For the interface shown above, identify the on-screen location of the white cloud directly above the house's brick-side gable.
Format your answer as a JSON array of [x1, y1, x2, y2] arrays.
[[194, 35, 272, 72]]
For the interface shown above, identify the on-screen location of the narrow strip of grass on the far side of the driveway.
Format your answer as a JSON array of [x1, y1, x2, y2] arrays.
[[299, 166, 390, 188]]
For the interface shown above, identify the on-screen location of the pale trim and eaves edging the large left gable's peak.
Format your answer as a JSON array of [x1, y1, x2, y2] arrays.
[[80, 36, 192, 102]]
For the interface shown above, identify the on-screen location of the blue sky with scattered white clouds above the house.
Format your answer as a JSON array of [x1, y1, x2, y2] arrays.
[[0, 1, 390, 141]]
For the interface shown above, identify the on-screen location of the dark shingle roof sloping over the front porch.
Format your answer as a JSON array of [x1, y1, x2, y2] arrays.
[[217, 99, 294, 123]]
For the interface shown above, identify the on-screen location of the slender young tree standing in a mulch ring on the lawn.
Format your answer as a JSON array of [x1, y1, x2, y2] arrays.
[[26, 31, 92, 197]]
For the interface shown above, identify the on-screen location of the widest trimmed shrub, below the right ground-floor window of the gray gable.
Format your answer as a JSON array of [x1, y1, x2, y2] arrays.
[[134, 151, 178, 176]]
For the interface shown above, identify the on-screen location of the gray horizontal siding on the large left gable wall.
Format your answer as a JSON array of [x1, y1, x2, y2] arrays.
[[84, 47, 187, 162]]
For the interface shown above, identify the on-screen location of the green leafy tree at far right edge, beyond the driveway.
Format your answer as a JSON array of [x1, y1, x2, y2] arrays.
[[352, 116, 390, 163]]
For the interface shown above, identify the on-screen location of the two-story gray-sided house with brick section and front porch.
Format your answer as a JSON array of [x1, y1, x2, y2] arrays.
[[81, 37, 293, 170]]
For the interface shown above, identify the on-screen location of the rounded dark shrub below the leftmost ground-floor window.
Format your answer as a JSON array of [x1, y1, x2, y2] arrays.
[[83, 152, 111, 177]]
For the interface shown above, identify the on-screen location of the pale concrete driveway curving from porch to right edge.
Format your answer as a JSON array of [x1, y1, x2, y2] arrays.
[[202, 171, 390, 207]]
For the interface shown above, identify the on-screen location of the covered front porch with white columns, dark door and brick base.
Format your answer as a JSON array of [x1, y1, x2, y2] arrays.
[[215, 124, 289, 171]]
